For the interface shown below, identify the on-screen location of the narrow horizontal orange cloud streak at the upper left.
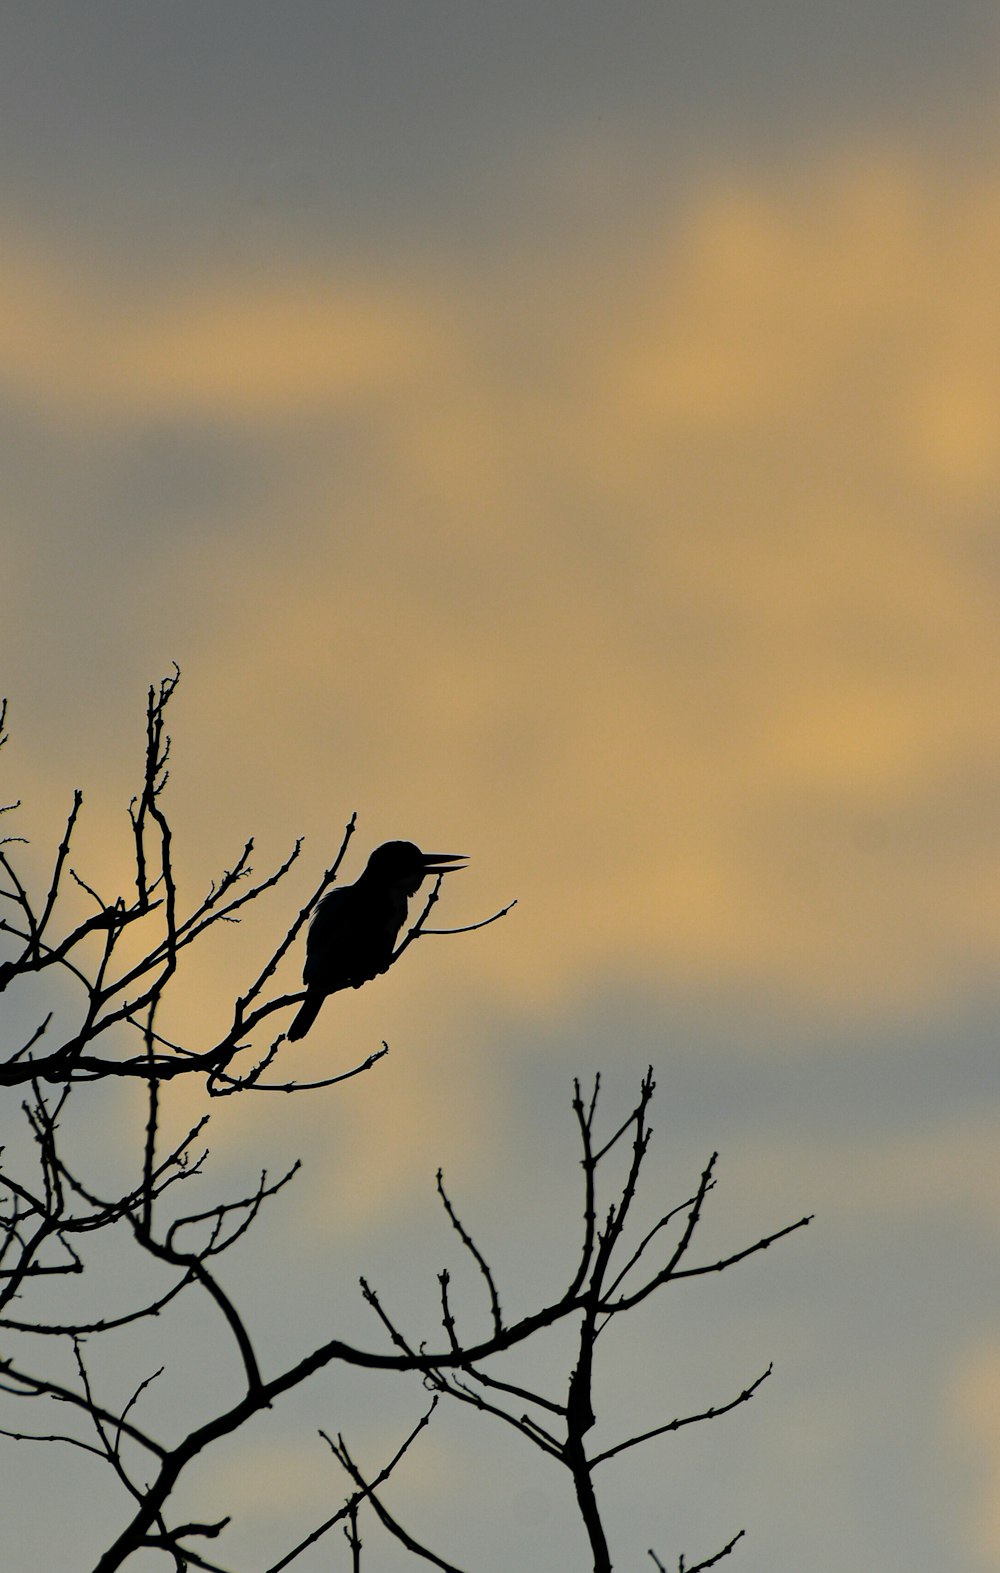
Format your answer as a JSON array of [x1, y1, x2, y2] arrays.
[[0, 245, 440, 429]]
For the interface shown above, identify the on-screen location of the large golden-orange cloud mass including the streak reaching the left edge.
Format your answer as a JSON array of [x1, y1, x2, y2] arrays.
[[8, 149, 1000, 1031]]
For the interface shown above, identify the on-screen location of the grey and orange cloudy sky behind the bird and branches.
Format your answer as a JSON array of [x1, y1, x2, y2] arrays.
[[0, 0, 1000, 1573]]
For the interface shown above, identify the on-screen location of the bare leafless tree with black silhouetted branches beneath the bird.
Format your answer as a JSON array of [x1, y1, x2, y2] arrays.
[[0, 669, 808, 1573]]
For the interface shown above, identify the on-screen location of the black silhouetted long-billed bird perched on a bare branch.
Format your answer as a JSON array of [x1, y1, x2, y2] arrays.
[[288, 842, 465, 1043]]
